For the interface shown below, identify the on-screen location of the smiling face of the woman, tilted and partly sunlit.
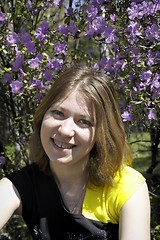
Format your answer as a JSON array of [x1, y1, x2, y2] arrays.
[[41, 90, 96, 169]]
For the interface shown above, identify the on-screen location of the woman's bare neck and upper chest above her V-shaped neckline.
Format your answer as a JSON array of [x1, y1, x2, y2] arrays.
[[51, 161, 88, 214]]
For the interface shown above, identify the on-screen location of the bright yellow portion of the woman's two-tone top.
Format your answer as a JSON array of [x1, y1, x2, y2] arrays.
[[82, 167, 145, 224]]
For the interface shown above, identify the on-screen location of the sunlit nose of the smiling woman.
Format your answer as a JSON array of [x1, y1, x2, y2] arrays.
[[58, 117, 75, 137]]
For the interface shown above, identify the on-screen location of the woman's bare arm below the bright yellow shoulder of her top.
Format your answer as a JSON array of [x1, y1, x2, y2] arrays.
[[119, 183, 150, 240]]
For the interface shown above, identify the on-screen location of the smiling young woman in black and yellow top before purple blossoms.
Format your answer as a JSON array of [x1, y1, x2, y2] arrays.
[[0, 67, 150, 240]]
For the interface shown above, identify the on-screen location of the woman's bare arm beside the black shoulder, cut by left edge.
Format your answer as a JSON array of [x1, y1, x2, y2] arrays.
[[0, 178, 21, 229]]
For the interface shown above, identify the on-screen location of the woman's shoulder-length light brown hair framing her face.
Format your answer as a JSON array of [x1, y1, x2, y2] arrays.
[[30, 67, 131, 185]]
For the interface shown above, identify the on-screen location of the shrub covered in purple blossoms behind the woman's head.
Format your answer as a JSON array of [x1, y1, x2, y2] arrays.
[[0, 0, 160, 165]]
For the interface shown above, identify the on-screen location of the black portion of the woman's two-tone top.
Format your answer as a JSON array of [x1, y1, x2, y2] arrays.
[[7, 164, 118, 240]]
